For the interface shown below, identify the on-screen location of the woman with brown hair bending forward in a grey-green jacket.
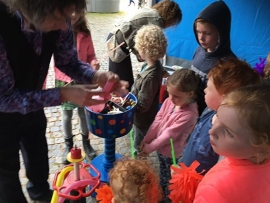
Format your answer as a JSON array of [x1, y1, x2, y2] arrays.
[[107, 0, 182, 90]]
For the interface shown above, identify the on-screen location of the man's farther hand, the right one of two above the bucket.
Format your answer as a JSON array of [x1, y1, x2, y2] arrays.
[[92, 71, 129, 96]]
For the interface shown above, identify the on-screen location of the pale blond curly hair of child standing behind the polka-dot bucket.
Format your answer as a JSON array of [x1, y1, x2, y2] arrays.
[[134, 25, 167, 61]]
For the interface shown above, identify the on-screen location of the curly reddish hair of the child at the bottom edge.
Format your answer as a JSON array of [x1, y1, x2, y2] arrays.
[[109, 158, 162, 203]]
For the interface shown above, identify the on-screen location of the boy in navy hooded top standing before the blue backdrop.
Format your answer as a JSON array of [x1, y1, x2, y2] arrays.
[[191, 1, 236, 115]]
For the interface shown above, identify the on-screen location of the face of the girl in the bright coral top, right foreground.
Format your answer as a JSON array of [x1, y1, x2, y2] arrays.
[[209, 106, 256, 159]]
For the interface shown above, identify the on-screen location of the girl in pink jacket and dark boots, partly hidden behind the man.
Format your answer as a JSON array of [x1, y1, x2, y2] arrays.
[[54, 13, 100, 164]]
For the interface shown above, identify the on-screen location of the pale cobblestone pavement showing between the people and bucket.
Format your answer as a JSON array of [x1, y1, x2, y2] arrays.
[[19, 0, 158, 202]]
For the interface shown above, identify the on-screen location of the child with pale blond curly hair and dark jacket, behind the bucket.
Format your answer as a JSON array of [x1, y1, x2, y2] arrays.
[[131, 25, 167, 159]]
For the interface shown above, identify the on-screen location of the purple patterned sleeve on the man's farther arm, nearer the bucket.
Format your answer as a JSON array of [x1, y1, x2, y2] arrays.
[[54, 23, 96, 84]]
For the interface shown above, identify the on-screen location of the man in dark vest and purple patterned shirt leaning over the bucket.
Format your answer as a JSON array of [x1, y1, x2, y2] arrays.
[[0, 0, 127, 203]]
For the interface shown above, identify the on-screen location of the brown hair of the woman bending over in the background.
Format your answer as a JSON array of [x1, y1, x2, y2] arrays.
[[152, 0, 182, 28]]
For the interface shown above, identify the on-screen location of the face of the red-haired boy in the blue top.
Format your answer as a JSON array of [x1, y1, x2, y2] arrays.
[[204, 77, 223, 110]]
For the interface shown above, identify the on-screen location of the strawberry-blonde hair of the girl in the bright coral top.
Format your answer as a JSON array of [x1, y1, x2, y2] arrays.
[[222, 85, 270, 149]]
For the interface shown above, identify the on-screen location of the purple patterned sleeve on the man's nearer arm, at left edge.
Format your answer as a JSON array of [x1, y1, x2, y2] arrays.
[[0, 37, 61, 114]]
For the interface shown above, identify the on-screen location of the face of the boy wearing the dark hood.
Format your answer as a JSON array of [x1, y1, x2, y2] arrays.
[[196, 22, 219, 52]]
